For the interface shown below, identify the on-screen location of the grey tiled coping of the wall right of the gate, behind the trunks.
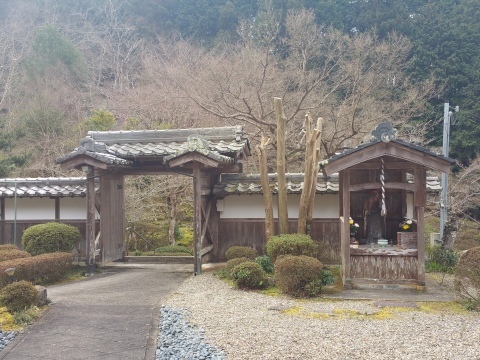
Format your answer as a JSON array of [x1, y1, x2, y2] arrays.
[[213, 173, 442, 197]]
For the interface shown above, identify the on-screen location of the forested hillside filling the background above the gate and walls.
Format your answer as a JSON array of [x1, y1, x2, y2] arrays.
[[0, 0, 480, 221]]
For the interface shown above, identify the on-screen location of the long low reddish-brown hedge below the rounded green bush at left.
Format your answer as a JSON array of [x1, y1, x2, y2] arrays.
[[0, 253, 73, 287]]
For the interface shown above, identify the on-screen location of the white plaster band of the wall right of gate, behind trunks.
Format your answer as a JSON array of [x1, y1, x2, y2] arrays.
[[220, 194, 340, 219]]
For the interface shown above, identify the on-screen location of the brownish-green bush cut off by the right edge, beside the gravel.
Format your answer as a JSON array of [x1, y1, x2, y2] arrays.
[[455, 246, 480, 310]]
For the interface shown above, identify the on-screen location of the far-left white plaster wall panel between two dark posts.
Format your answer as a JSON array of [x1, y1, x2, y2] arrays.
[[5, 198, 55, 220]]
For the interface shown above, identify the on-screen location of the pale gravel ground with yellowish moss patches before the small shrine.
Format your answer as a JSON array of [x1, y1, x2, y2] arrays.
[[164, 273, 480, 360]]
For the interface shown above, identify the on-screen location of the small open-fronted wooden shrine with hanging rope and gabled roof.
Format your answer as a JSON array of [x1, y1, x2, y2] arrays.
[[321, 123, 454, 289]]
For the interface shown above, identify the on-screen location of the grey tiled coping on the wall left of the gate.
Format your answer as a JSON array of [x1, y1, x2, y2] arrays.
[[0, 177, 98, 197]]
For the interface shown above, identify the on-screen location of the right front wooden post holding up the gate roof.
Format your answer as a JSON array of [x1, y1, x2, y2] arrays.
[[193, 162, 202, 275]]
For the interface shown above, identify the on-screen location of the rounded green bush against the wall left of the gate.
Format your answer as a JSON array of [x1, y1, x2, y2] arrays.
[[22, 222, 80, 256]]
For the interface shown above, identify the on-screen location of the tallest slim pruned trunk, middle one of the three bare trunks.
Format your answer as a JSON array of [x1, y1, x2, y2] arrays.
[[273, 98, 290, 234]]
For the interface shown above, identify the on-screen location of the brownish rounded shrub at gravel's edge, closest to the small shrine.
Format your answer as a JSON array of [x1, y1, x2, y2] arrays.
[[275, 255, 323, 297]]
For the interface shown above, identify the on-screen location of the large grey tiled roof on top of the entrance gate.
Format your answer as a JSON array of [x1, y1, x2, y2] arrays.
[[57, 126, 250, 166]]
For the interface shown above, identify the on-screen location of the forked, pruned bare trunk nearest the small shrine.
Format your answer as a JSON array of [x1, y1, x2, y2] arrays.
[[297, 114, 322, 234]]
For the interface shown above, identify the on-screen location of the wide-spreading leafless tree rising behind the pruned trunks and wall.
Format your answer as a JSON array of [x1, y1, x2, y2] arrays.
[[155, 10, 434, 167]]
